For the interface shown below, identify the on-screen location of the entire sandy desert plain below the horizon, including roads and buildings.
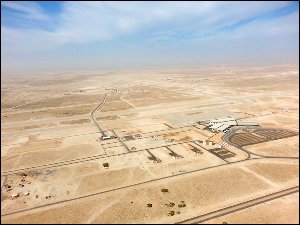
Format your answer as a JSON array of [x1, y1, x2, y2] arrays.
[[1, 65, 299, 224]]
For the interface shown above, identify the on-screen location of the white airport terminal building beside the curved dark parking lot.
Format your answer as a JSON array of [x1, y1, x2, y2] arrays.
[[208, 117, 259, 132]]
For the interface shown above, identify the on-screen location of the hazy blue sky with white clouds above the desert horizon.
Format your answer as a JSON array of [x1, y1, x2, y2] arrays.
[[1, 1, 299, 74]]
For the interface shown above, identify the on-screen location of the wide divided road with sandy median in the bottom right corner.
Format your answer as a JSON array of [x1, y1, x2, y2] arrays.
[[178, 186, 299, 224]]
